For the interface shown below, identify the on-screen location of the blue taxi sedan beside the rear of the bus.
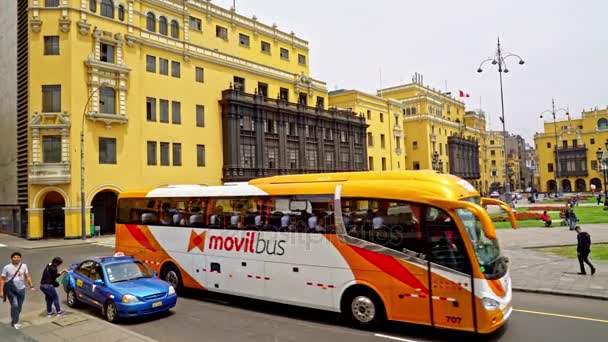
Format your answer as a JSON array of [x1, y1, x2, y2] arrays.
[[62, 255, 177, 322]]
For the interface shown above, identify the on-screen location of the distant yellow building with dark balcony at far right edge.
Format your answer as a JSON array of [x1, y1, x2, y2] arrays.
[[534, 109, 608, 192]]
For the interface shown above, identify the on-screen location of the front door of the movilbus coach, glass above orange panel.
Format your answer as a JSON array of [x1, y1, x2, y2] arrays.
[[424, 207, 475, 331]]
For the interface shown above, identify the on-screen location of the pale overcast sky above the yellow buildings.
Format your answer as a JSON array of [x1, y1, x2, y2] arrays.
[[213, 0, 608, 145]]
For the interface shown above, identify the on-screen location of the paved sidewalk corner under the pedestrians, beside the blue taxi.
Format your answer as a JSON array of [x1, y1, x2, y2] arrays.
[[0, 311, 155, 342]]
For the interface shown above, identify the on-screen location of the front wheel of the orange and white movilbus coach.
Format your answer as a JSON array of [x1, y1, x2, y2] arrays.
[[342, 288, 386, 329]]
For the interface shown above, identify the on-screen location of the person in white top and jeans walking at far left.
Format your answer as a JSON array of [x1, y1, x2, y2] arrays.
[[0, 252, 36, 329]]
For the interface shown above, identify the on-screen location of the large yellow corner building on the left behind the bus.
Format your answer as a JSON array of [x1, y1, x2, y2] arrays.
[[0, 0, 366, 239]]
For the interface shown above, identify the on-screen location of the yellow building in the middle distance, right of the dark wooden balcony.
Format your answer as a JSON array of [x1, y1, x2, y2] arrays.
[[329, 77, 490, 192]]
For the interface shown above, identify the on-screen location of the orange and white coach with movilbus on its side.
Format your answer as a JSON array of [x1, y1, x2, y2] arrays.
[[116, 171, 516, 333]]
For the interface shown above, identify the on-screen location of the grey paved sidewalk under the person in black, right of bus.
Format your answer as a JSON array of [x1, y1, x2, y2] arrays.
[[497, 224, 608, 300]]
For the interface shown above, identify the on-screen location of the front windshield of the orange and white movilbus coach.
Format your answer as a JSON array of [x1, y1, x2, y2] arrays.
[[456, 200, 507, 279]]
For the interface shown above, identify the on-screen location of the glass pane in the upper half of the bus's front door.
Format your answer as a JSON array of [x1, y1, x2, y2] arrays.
[[425, 207, 471, 274]]
